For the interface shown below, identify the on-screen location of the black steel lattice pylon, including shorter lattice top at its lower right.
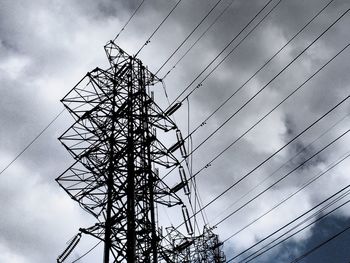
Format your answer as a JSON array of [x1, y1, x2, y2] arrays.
[[57, 41, 224, 263]]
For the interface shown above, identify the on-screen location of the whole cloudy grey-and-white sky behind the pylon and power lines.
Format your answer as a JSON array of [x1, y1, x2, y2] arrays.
[[0, 0, 350, 263]]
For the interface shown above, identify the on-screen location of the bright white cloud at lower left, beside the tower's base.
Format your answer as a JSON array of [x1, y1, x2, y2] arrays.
[[0, 153, 92, 262]]
